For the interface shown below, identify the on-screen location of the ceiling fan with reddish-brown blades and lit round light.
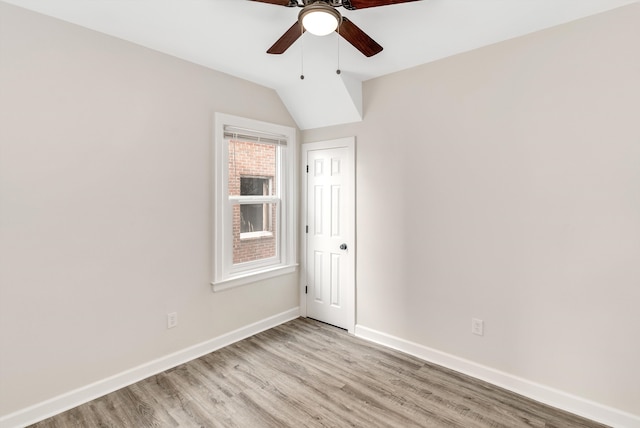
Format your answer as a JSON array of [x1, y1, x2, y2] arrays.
[[251, 0, 416, 57]]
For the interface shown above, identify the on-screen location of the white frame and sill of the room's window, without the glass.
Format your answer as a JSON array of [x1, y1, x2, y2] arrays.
[[211, 113, 298, 291]]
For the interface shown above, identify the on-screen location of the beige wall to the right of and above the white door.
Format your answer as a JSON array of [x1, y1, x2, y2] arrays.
[[303, 4, 640, 415]]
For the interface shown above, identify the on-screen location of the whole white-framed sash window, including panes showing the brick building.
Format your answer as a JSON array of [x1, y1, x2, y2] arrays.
[[212, 113, 296, 291]]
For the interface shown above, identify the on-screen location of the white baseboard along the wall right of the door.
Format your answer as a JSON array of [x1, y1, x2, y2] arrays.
[[356, 325, 640, 428]]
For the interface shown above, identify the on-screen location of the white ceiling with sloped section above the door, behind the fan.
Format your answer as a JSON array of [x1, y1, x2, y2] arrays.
[[3, 0, 638, 129]]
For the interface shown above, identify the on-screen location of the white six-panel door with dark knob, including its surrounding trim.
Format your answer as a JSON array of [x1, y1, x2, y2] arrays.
[[303, 138, 355, 332]]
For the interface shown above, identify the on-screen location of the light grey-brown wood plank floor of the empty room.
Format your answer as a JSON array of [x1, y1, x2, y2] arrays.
[[33, 318, 603, 428]]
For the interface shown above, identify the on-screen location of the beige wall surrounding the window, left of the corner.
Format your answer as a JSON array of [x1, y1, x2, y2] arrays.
[[0, 2, 298, 415]]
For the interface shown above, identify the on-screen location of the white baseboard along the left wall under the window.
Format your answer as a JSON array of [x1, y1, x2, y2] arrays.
[[0, 308, 300, 428]]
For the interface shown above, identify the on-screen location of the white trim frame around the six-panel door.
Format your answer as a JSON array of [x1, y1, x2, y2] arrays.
[[300, 137, 356, 334]]
